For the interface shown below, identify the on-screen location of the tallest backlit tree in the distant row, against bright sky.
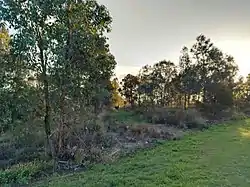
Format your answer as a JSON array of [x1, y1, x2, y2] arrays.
[[191, 35, 238, 109]]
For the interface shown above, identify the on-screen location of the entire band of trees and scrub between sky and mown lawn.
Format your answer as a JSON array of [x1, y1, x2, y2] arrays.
[[0, 0, 250, 185]]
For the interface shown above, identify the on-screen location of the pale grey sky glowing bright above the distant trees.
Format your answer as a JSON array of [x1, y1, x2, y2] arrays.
[[98, 0, 250, 78]]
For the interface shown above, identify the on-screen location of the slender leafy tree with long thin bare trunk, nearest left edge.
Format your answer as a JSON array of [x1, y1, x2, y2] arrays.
[[0, 0, 61, 152]]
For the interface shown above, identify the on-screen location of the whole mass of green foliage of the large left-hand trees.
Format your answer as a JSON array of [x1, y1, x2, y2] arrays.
[[0, 0, 116, 161]]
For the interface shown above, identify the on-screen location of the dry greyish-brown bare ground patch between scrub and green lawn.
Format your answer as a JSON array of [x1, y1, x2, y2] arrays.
[[105, 123, 186, 160]]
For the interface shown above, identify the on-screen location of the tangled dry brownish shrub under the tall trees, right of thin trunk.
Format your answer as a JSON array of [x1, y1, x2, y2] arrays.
[[52, 108, 114, 165]]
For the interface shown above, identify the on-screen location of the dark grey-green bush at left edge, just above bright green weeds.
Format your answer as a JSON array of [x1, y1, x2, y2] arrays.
[[0, 124, 44, 168]]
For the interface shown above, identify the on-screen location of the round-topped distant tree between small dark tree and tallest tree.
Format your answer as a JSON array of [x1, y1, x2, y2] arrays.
[[136, 60, 177, 106]]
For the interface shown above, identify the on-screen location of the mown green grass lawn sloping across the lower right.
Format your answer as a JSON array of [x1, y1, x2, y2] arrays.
[[37, 120, 250, 187]]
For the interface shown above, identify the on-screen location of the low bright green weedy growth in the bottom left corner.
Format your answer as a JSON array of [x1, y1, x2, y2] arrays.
[[0, 161, 52, 185]]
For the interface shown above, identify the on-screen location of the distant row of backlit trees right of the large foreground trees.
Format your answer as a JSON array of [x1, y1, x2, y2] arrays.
[[116, 35, 250, 114]]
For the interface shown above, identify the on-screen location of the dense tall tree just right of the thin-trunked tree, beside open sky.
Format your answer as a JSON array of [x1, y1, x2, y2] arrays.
[[49, 0, 116, 152]]
